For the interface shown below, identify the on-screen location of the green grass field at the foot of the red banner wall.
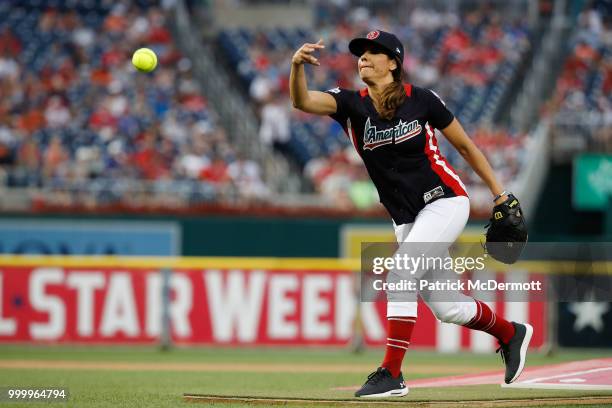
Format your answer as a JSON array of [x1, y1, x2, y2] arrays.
[[0, 346, 612, 407]]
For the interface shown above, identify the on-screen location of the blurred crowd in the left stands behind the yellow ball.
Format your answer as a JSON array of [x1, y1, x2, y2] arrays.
[[0, 0, 267, 206]]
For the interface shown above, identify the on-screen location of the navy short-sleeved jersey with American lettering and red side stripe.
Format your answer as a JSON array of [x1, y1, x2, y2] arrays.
[[326, 84, 467, 225]]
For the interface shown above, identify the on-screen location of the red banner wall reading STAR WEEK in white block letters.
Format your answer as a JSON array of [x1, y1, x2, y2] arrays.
[[0, 258, 547, 351]]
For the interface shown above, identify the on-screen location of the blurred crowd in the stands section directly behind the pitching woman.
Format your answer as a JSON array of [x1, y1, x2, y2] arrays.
[[219, 0, 530, 214]]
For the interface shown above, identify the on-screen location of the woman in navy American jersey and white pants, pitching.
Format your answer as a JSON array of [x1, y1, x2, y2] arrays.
[[290, 31, 533, 397]]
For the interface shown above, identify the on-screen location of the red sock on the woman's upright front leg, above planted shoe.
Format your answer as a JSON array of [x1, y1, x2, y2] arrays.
[[381, 316, 416, 377]]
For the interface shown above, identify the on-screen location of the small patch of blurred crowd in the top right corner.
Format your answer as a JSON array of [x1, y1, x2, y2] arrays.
[[547, 0, 612, 151]]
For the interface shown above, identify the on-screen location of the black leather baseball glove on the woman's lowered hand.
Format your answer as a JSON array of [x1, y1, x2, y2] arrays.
[[485, 194, 527, 264]]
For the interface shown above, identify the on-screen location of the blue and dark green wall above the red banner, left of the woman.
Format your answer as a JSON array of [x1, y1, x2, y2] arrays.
[[0, 214, 393, 257]]
